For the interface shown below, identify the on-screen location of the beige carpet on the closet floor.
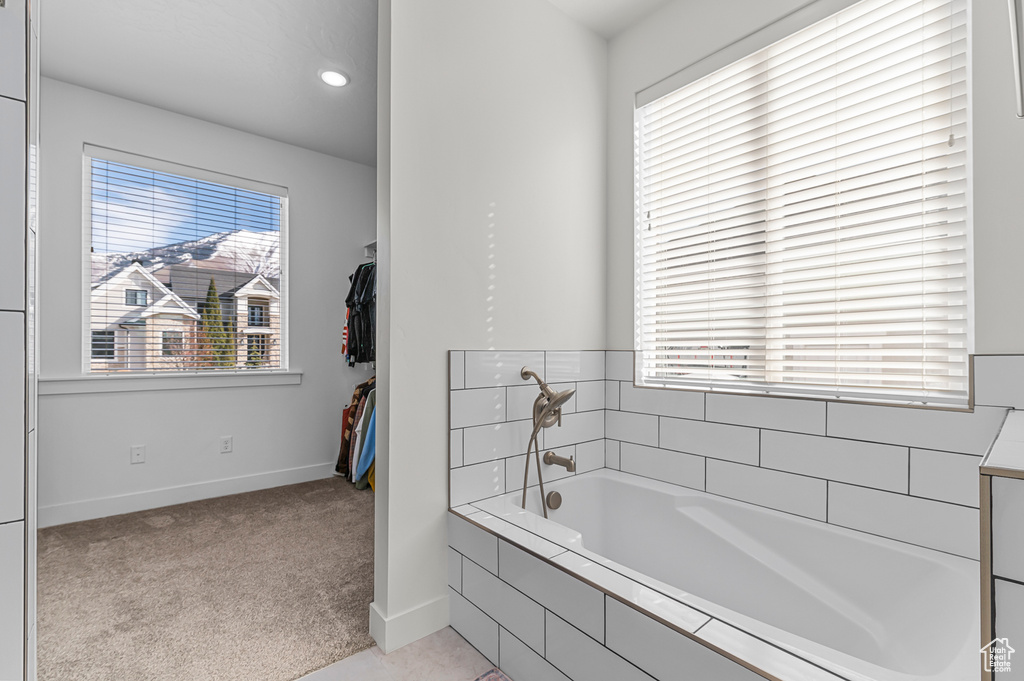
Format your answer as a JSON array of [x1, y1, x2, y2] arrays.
[[38, 478, 374, 681]]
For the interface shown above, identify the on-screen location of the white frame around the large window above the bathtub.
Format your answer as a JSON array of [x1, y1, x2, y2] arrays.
[[633, 0, 976, 411]]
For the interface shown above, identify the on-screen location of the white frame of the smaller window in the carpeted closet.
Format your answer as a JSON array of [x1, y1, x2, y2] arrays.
[[80, 143, 290, 376]]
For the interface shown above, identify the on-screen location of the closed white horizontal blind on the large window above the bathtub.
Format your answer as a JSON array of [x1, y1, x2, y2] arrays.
[[636, 0, 970, 402]]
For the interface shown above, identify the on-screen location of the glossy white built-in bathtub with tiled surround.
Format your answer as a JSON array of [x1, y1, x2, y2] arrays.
[[473, 469, 980, 681]]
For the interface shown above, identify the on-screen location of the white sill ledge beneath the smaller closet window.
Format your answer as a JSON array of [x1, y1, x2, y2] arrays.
[[39, 372, 302, 395]]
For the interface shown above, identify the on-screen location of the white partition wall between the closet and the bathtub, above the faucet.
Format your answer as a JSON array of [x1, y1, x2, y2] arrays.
[[371, 0, 606, 650]]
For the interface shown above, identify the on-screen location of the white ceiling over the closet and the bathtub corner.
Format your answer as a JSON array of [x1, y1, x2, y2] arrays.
[[40, 0, 668, 165]]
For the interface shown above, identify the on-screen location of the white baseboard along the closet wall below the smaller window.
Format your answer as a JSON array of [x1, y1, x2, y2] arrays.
[[38, 463, 334, 527]]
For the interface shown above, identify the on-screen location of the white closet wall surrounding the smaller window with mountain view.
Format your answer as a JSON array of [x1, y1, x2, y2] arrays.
[[39, 79, 375, 525]]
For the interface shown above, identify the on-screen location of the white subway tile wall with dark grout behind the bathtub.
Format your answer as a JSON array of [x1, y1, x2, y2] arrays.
[[451, 351, 1024, 559]]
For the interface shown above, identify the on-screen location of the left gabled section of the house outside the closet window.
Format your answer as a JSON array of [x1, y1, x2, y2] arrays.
[[90, 262, 200, 372]]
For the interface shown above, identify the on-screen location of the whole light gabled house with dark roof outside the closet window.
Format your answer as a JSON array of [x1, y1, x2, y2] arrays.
[[90, 261, 281, 372]]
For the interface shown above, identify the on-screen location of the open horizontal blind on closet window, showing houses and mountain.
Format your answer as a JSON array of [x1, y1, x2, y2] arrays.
[[84, 154, 286, 373]]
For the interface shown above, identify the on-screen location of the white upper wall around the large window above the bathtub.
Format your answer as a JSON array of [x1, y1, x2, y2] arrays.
[[607, 0, 1024, 353]]
